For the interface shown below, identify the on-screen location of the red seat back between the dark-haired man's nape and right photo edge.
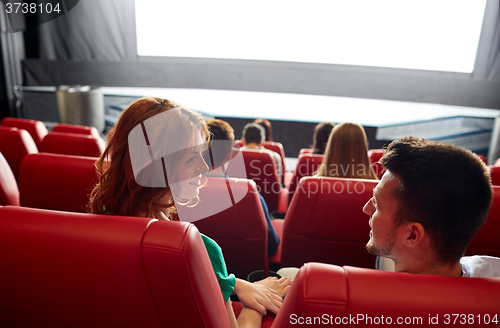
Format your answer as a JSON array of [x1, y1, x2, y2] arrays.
[[465, 186, 500, 257]]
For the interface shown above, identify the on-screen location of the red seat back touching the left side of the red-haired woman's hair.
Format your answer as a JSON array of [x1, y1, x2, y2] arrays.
[[19, 153, 97, 212]]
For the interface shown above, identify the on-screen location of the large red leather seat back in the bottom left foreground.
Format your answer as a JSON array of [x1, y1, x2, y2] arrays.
[[0, 206, 229, 328]]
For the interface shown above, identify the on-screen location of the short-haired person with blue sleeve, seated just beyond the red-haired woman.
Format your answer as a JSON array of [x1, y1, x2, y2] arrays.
[[205, 119, 280, 256]]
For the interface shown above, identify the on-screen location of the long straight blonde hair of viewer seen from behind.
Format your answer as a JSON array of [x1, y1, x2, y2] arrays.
[[314, 123, 377, 179]]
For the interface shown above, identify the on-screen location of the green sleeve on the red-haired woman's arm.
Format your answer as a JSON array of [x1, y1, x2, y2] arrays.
[[200, 233, 236, 303]]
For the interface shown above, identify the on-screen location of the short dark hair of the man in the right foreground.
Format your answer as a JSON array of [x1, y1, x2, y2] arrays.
[[380, 137, 492, 263]]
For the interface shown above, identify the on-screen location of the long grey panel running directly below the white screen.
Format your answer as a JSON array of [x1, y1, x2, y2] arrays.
[[23, 58, 500, 109]]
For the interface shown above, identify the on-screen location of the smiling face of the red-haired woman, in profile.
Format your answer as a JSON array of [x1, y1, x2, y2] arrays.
[[170, 133, 209, 200]]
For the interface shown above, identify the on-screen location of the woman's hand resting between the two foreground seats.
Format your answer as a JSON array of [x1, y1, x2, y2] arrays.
[[234, 278, 283, 315]]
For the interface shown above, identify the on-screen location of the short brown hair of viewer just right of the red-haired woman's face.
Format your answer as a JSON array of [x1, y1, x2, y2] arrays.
[[207, 119, 234, 170]]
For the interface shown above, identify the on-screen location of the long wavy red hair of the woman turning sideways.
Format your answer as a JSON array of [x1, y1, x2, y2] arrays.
[[87, 97, 210, 220]]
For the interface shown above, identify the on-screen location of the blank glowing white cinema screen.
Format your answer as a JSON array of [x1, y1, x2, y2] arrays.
[[135, 0, 486, 73]]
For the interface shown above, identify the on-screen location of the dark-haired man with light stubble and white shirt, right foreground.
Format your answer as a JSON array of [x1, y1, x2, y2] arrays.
[[363, 137, 500, 277]]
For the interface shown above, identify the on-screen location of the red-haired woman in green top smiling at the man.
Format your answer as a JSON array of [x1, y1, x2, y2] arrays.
[[89, 97, 289, 328]]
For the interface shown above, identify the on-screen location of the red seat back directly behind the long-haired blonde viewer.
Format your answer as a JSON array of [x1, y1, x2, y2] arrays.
[[270, 177, 378, 268]]
